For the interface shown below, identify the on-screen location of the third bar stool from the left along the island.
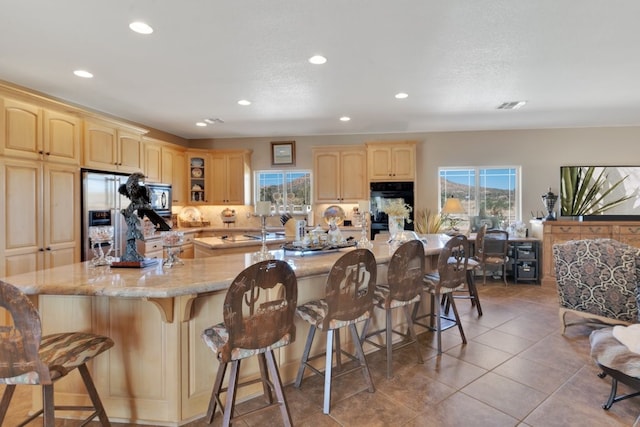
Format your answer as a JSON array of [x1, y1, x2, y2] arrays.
[[295, 249, 377, 414]]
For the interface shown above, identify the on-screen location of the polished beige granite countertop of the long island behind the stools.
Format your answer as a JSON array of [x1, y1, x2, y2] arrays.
[[2, 235, 448, 298]]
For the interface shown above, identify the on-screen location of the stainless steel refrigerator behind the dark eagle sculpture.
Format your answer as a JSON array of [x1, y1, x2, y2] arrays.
[[82, 170, 130, 261]]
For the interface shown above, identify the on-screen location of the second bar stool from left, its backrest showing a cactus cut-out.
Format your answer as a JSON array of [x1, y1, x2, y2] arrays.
[[202, 260, 298, 426]]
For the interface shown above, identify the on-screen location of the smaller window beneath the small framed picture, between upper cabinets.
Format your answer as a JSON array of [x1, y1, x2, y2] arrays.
[[254, 169, 311, 210]]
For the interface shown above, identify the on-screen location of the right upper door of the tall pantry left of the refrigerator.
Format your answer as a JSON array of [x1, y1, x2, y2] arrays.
[[43, 110, 81, 165]]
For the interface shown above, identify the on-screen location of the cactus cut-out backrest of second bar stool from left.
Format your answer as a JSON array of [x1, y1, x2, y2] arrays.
[[219, 260, 298, 362]]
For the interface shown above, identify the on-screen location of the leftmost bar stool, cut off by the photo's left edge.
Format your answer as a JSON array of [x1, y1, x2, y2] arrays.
[[0, 281, 113, 427]]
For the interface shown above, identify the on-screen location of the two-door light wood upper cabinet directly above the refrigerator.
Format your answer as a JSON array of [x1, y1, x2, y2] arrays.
[[83, 120, 144, 173]]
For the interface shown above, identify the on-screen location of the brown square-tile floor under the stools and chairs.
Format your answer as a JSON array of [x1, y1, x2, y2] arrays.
[[4, 281, 640, 427]]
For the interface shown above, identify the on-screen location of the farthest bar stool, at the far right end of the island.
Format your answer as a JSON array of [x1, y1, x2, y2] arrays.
[[413, 235, 469, 355]]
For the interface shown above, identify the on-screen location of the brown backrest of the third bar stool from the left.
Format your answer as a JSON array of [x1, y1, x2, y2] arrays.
[[323, 249, 377, 330]]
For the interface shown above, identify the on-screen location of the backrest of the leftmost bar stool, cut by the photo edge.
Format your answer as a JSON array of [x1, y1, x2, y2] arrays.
[[0, 281, 52, 385]]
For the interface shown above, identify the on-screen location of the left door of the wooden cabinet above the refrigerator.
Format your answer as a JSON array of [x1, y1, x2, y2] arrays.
[[83, 120, 118, 170]]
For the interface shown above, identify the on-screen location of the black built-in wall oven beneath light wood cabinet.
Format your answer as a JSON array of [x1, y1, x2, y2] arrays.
[[369, 181, 415, 239]]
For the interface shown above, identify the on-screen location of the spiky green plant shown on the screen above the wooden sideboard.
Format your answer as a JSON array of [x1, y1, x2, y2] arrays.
[[560, 166, 631, 216]]
